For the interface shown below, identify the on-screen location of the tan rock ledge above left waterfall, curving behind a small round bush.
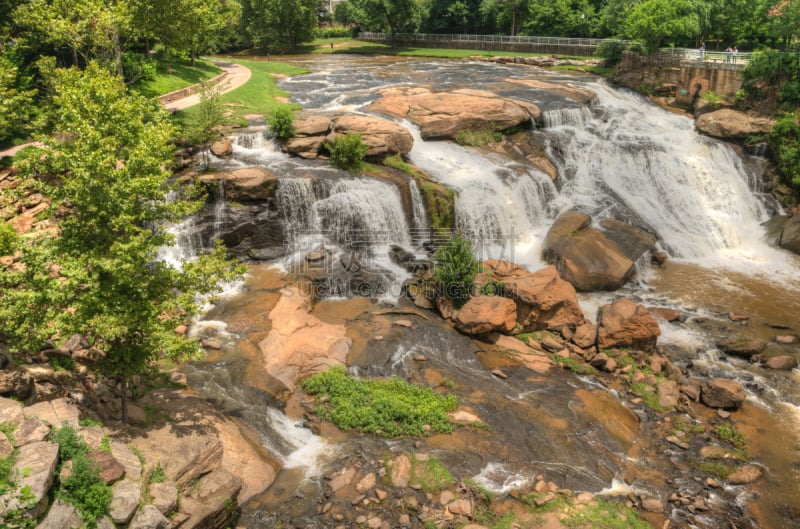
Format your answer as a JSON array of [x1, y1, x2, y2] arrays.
[[284, 112, 414, 158]]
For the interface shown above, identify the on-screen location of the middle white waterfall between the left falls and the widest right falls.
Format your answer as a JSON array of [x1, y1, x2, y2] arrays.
[[405, 123, 556, 267]]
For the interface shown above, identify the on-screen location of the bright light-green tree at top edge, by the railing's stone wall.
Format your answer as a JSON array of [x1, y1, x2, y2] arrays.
[[625, 0, 700, 54]]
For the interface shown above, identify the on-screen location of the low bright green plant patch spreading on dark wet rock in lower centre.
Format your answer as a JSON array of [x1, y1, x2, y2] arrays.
[[301, 366, 457, 437]]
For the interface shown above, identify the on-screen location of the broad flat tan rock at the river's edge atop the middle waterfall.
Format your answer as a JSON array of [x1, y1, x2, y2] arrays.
[[366, 88, 531, 140]]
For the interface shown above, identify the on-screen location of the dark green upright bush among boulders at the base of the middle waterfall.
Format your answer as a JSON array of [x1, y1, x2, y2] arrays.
[[433, 235, 481, 307]]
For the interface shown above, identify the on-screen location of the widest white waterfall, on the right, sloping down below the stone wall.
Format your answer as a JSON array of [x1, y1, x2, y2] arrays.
[[545, 83, 786, 278]]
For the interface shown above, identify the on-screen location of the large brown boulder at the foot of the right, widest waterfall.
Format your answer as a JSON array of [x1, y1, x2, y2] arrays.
[[543, 211, 635, 292]]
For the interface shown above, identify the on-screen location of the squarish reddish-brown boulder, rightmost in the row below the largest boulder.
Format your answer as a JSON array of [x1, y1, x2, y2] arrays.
[[597, 298, 661, 351]]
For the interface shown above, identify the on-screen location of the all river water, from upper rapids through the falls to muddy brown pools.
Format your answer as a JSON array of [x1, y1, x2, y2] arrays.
[[179, 55, 800, 529]]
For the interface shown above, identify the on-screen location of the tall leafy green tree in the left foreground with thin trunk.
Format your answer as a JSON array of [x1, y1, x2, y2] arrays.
[[0, 61, 241, 420]]
